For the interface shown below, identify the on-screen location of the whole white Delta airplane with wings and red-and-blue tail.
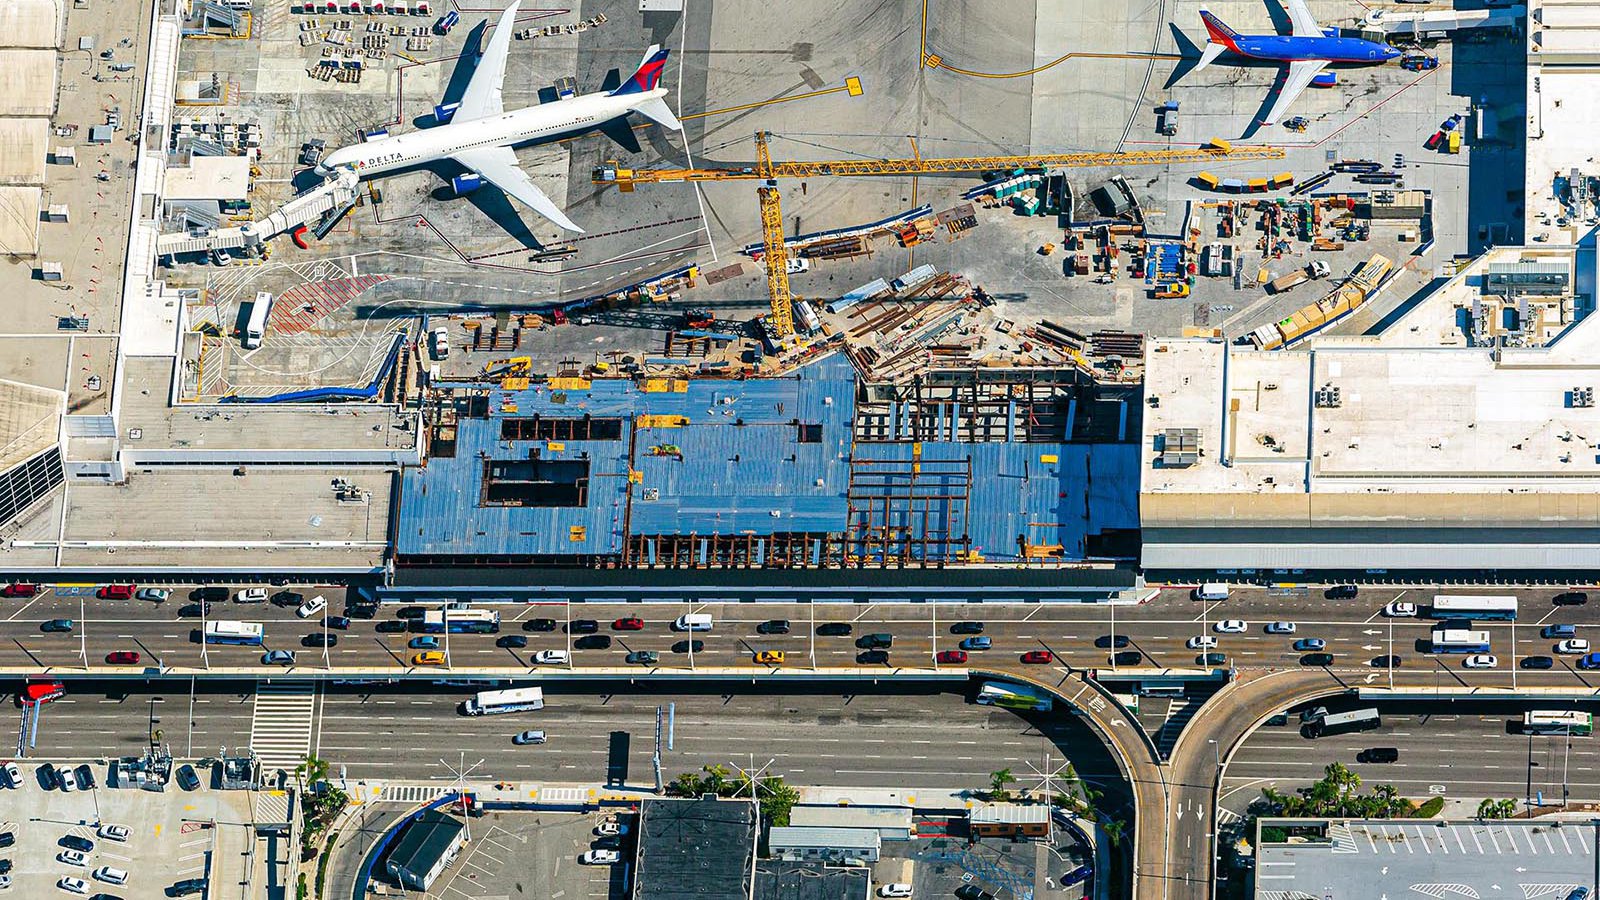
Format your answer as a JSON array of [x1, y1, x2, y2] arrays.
[[317, 0, 683, 232]]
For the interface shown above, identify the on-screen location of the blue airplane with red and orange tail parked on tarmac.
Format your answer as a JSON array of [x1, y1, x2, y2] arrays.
[[1192, 0, 1400, 125]]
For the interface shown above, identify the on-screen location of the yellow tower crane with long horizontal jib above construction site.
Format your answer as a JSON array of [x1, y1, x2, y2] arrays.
[[594, 131, 1283, 338]]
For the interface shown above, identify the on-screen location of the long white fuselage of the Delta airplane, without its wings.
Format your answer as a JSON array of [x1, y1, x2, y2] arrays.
[[317, 88, 667, 178]]
